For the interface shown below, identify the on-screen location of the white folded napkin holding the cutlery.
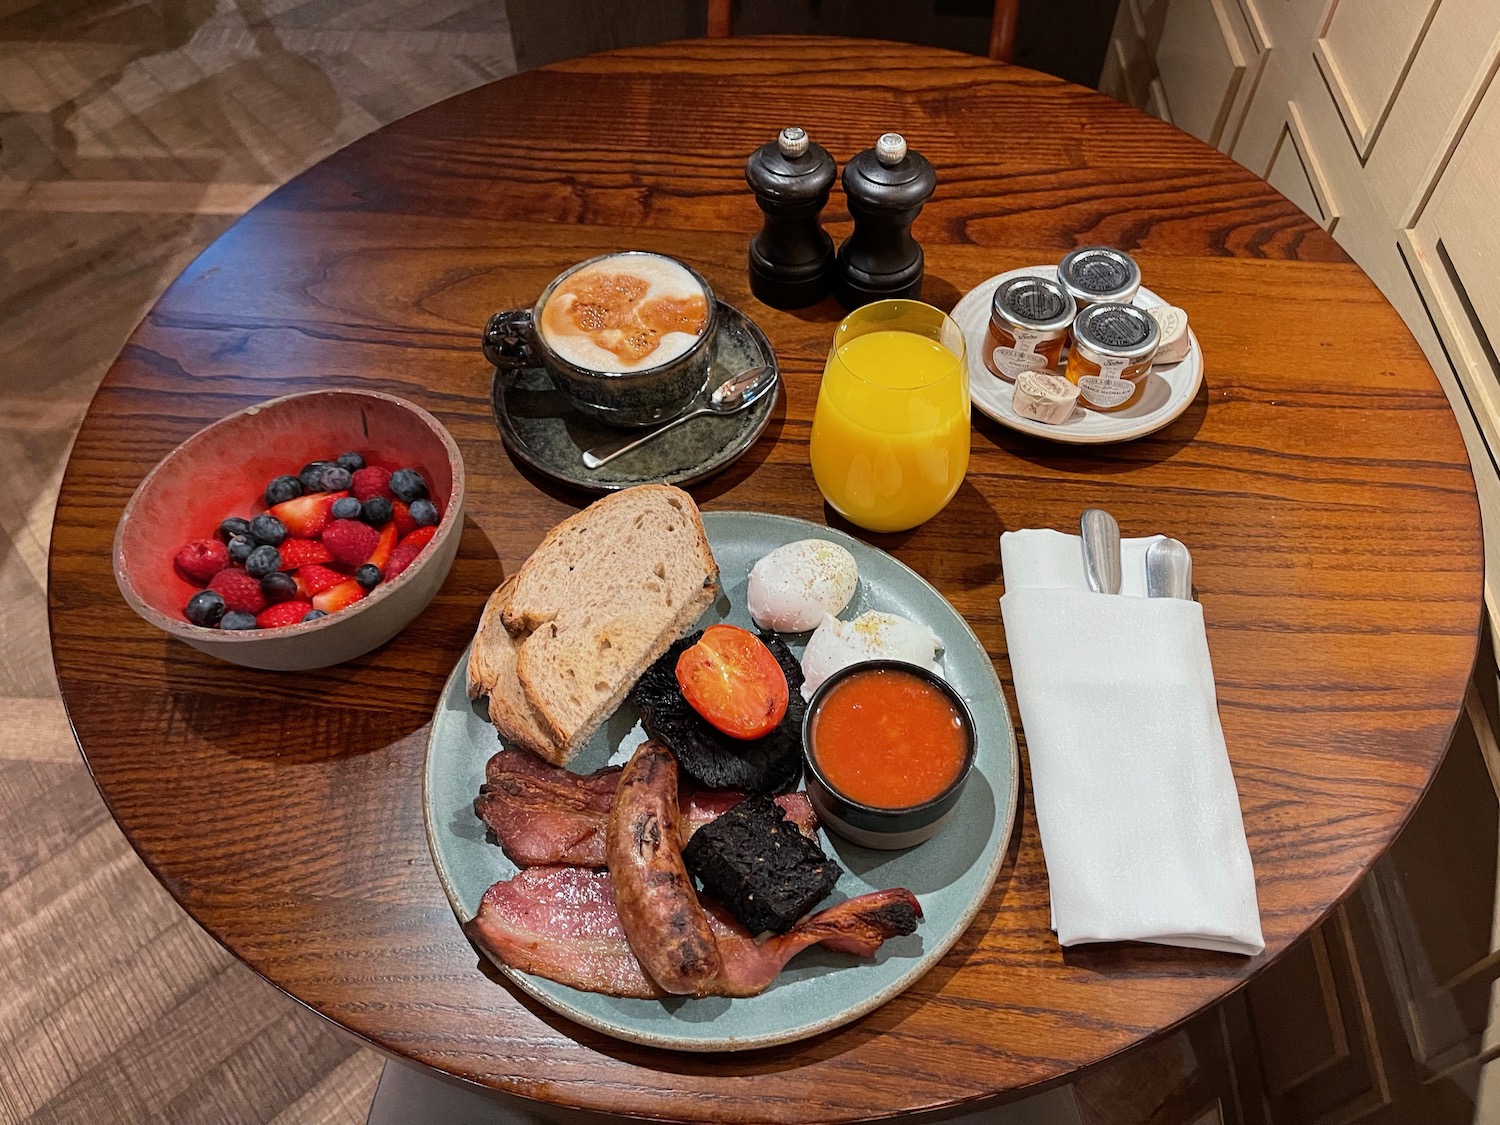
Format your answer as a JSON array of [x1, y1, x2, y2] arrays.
[[1001, 531, 1266, 956]]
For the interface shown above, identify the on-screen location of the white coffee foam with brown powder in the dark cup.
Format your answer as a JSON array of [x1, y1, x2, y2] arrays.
[[542, 254, 708, 372]]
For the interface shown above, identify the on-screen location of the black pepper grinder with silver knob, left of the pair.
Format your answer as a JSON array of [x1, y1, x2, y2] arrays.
[[746, 126, 837, 309]]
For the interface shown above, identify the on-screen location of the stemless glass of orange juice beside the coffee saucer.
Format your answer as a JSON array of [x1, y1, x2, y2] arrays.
[[809, 300, 969, 531]]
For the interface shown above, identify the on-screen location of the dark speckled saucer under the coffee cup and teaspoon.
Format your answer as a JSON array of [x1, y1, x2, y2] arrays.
[[489, 302, 780, 492]]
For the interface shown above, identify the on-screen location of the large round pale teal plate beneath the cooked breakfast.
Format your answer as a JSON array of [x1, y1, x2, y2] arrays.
[[425, 512, 1019, 1052]]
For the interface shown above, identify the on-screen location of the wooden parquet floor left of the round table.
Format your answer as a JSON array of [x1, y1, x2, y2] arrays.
[[0, 0, 515, 1125]]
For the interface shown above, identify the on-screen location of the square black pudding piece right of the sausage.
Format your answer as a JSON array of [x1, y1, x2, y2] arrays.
[[683, 797, 843, 935]]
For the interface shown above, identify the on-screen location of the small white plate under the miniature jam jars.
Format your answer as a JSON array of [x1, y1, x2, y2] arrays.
[[953, 266, 1203, 446]]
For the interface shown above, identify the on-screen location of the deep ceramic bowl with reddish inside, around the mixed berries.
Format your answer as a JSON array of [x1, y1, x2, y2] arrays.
[[114, 390, 464, 671]]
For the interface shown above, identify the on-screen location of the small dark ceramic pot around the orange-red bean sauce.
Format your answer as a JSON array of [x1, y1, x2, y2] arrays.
[[803, 660, 978, 851]]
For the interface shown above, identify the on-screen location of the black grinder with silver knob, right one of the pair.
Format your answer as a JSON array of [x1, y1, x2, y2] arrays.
[[834, 134, 938, 309]]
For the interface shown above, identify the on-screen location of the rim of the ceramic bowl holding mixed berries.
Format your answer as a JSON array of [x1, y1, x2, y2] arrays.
[[111, 387, 465, 645]]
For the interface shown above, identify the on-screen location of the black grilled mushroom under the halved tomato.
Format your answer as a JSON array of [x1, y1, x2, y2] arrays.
[[630, 630, 807, 794]]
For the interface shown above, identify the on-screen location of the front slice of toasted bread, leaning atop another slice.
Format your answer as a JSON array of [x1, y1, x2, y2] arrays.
[[504, 485, 719, 765]]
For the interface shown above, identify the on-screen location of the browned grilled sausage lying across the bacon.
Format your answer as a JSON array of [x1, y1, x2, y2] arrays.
[[605, 743, 723, 996]]
